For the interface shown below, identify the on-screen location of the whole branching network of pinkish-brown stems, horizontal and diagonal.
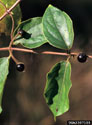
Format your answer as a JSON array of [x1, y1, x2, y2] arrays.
[[0, 0, 92, 60]]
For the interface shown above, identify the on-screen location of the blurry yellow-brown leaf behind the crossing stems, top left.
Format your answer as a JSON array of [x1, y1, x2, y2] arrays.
[[0, 0, 21, 35]]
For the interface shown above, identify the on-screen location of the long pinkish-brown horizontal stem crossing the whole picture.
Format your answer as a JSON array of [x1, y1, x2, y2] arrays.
[[0, 47, 92, 58]]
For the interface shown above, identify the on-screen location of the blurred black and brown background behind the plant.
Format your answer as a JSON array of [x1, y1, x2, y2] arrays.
[[0, 0, 92, 125]]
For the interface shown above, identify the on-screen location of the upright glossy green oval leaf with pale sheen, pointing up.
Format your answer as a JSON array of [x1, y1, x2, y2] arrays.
[[42, 5, 74, 50]]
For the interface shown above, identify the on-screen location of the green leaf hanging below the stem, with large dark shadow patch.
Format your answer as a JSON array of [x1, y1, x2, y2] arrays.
[[44, 61, 72, 117]]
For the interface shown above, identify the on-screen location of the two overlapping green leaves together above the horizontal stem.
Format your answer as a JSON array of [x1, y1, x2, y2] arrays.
[[14, 5, 74, 50]]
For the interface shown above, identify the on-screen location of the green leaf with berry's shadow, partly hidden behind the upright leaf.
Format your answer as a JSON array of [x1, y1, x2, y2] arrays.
[[14, 17, 47, 49]]
